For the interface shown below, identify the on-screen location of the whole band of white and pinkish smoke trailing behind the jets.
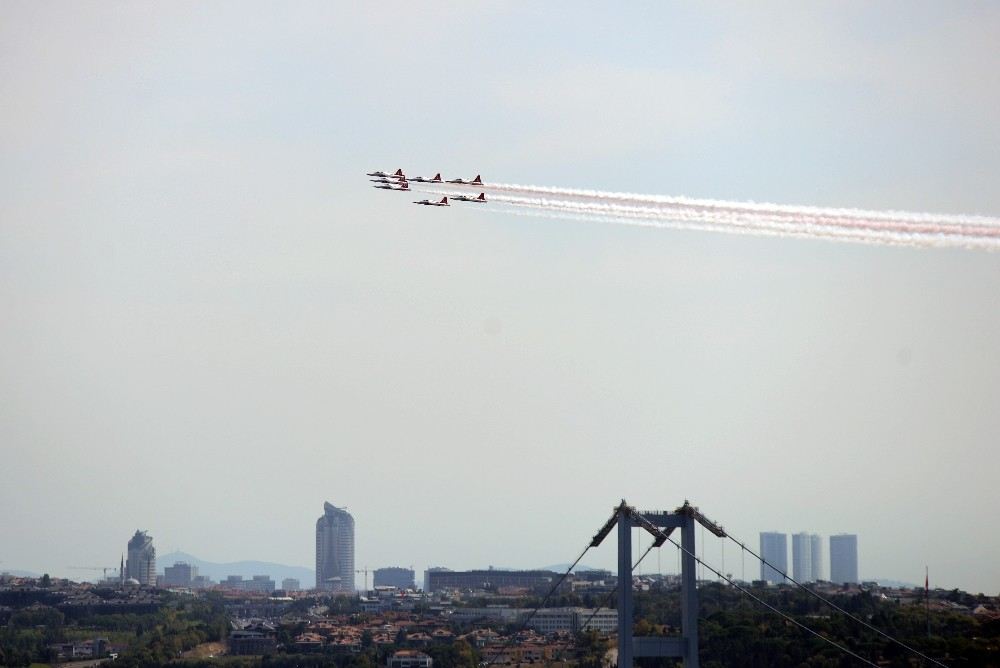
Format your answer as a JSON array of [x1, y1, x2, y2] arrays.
[[406, 184, 1000, 250]]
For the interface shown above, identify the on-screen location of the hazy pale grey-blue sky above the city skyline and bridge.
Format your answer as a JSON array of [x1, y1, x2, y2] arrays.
[[0, 0, 1000, 594]]
